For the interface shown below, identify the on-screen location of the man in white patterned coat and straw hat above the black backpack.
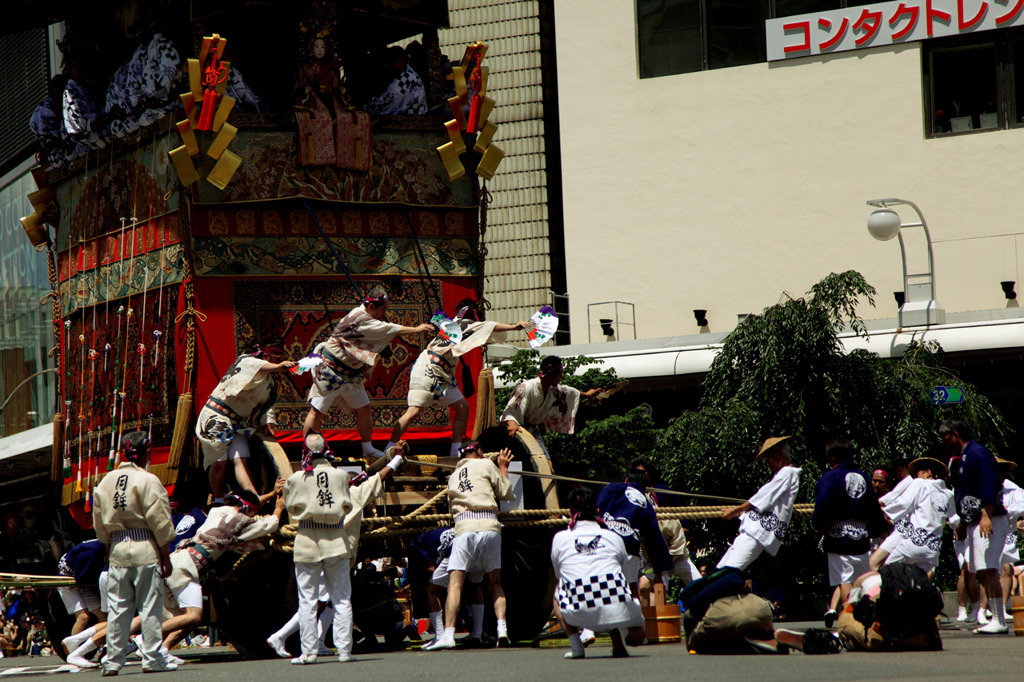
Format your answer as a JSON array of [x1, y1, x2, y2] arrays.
[[871, 457, 959, 578]]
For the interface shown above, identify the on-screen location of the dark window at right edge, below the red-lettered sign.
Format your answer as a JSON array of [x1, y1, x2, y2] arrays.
[[922, 31, 1024, 137]]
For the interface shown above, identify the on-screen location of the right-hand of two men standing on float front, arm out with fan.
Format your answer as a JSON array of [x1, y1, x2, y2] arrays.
[[388, 298, 528, 457]]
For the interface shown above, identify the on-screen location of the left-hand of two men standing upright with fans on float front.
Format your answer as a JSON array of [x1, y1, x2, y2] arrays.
[[302, 287, 433, 457]]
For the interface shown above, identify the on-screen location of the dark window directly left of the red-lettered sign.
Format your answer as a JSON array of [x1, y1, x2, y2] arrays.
[[636, 0, 866, 78]]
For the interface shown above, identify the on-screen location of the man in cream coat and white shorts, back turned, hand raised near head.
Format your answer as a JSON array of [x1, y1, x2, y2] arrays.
[[423, 442, 515, 651]]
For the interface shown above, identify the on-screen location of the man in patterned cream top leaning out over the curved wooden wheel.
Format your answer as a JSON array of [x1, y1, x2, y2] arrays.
[[499, 355, 601, 458]]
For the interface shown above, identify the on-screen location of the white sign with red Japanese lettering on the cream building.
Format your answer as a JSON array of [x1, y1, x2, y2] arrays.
[[765, 0, 1024, 61]]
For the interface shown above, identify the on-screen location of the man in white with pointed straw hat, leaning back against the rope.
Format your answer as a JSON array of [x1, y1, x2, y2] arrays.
[[718, 436, 800, 570]]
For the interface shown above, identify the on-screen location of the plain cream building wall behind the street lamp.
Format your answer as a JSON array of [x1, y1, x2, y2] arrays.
[[555, 0, 1024, 343]]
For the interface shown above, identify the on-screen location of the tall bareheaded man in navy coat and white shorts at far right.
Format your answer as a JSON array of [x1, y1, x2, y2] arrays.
[[939, 419, 1009, 635]]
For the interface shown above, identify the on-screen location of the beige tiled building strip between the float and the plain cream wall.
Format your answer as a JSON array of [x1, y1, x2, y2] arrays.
[[438, 0, 564, 342]]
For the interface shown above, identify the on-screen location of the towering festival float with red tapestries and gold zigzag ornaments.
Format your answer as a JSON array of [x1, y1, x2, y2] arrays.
[[26, 0, 558, 656]]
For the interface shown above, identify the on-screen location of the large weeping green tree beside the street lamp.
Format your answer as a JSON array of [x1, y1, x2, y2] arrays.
[[653, 270, 1010, 587]]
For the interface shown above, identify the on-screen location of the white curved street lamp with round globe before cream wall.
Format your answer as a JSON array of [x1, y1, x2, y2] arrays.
[[867, 199, 946, 328]]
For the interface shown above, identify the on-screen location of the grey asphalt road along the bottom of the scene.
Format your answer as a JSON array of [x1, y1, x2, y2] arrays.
[[0, 624, 1024, 682]]
